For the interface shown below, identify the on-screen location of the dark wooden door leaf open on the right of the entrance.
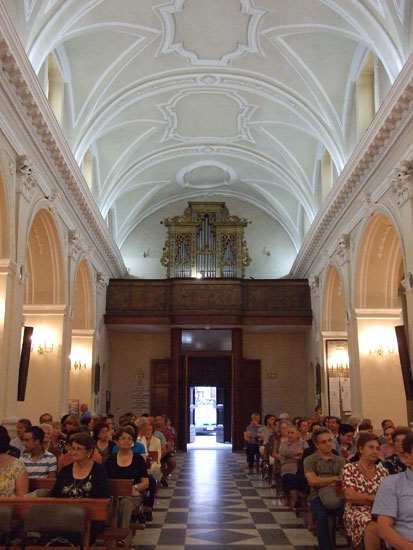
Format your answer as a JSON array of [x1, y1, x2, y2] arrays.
[[232, 359, 261, 451]]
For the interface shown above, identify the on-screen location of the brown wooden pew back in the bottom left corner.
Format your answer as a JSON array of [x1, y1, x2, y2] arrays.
[[0, 496, 109, 550]]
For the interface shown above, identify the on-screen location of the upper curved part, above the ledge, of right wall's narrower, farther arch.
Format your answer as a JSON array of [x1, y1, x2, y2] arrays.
[[321, 265, 346, 332]]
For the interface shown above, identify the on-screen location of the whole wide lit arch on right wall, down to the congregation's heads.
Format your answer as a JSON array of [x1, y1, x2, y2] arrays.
[[355, 214, 407, 425]]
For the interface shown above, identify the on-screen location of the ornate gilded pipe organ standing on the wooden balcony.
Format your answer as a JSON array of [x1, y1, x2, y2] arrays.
[[161, 202, 251, 279]]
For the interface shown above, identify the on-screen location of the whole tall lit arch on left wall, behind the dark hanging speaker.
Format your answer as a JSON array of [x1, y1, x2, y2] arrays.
[[17, 210, 67, 420]]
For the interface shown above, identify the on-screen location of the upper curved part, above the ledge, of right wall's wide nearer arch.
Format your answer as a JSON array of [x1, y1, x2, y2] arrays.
[[355, 214, 404, 309]]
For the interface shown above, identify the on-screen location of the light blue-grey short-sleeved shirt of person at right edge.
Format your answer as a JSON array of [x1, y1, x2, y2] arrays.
[[371, 468, 413, 542]]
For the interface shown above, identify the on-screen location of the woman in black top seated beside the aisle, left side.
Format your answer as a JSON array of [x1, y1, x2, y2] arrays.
[[105, 428, 149, 527]]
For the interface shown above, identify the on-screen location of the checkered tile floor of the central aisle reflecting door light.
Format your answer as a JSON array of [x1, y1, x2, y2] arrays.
[[134, 449, 317, 550]]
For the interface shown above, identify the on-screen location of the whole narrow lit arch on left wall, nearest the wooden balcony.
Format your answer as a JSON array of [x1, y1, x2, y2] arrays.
[[70, 260, 99, 405]]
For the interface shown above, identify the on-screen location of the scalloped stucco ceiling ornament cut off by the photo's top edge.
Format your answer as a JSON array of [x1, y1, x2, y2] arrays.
[[154, 0, 267, 67]]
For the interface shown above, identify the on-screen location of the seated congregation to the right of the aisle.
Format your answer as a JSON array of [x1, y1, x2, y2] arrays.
[[244, 407, 413, 550]]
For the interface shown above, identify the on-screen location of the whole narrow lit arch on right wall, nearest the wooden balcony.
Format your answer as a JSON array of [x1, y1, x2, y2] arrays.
[[322, 265, 351, 420]]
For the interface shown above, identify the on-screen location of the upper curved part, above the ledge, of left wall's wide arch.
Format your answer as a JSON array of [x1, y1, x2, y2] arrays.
[[24, 209, 65, 305]]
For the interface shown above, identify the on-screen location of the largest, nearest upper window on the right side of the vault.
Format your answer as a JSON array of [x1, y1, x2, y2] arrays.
[[356, 53, 376, 139]]
